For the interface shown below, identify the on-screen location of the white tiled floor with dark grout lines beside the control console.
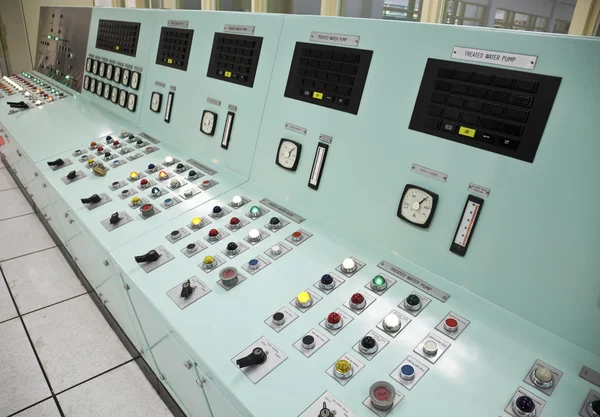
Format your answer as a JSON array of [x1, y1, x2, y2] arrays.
[[0, 165, 172, 417]]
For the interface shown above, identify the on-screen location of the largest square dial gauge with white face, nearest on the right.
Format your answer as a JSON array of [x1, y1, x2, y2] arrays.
[[397, 184, 438, 229]]
